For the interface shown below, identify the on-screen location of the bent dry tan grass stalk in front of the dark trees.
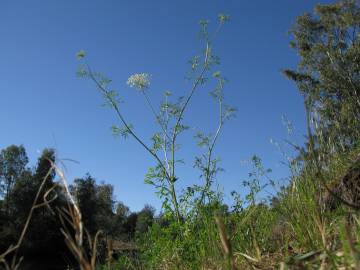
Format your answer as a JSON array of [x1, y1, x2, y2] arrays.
[[0, 160, 101, 270]]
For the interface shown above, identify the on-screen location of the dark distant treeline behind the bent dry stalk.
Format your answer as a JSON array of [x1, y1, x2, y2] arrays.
[[0, 145, 155, 269]]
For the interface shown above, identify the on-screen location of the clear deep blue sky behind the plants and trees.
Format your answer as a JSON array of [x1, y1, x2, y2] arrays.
[[0, 0, 329, 210]]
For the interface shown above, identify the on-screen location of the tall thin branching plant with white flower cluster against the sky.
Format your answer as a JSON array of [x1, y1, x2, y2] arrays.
[[77, 14, 234, 222]]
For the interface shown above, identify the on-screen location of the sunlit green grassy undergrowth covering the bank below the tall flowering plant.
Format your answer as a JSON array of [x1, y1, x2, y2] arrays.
[[107, 143, 360, 269]]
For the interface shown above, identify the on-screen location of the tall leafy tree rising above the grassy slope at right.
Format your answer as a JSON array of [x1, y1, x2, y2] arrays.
[[284, 0, 360, 156]]
